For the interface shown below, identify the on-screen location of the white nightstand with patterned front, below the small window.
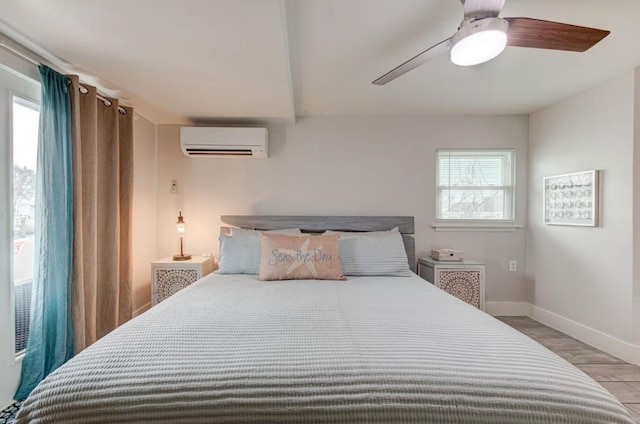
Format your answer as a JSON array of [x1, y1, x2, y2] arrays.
[[418, 258, 484, 310]]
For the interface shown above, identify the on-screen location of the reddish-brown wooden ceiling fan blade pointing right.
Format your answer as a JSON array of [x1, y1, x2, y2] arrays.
[[505, 18, 610, 52]]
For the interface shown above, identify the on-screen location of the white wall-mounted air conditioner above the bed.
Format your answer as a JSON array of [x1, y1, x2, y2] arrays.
[[180, 127, 269, 159]]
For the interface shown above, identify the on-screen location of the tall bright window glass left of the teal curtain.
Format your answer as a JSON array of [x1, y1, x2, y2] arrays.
[[12, 96, 40, 354]]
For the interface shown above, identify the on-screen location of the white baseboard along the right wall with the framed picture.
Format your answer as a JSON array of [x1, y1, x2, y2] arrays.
[[528, 304, 640, 365]]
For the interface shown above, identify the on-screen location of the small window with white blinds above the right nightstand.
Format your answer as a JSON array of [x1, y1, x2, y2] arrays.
[[436, 149, 515, 223]]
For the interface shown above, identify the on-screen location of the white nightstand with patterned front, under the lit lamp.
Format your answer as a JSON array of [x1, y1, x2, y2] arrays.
[[151, 256, 213, 306]]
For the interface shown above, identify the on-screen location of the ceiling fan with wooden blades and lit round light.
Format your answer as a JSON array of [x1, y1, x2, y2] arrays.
[[373, 0, 610, 85]]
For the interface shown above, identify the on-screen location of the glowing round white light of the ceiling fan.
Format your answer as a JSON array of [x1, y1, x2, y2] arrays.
[[451, 18, 509, 66]]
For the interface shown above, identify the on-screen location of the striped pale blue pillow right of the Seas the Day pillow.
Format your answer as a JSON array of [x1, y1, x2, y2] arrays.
[[324, 230, 411, 277]]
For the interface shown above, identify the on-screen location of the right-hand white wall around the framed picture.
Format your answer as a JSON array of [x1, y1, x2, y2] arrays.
[[527, 72, 634, 342]]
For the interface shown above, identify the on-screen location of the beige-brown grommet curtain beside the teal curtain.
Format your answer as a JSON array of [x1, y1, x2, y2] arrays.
[[70, 76, 133, 352]]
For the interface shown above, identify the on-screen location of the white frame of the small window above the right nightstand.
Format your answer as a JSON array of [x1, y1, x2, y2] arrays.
[[433, 148, 521, 231]]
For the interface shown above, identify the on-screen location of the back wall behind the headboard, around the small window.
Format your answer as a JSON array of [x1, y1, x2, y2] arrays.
[[157, 116, 528, 301]]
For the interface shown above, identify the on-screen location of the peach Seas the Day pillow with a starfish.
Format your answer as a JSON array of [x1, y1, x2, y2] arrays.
[[258, 233, 345, 280]]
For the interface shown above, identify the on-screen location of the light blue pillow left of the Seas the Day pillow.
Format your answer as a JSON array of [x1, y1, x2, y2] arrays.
[[217, 235, 260, 275]]
